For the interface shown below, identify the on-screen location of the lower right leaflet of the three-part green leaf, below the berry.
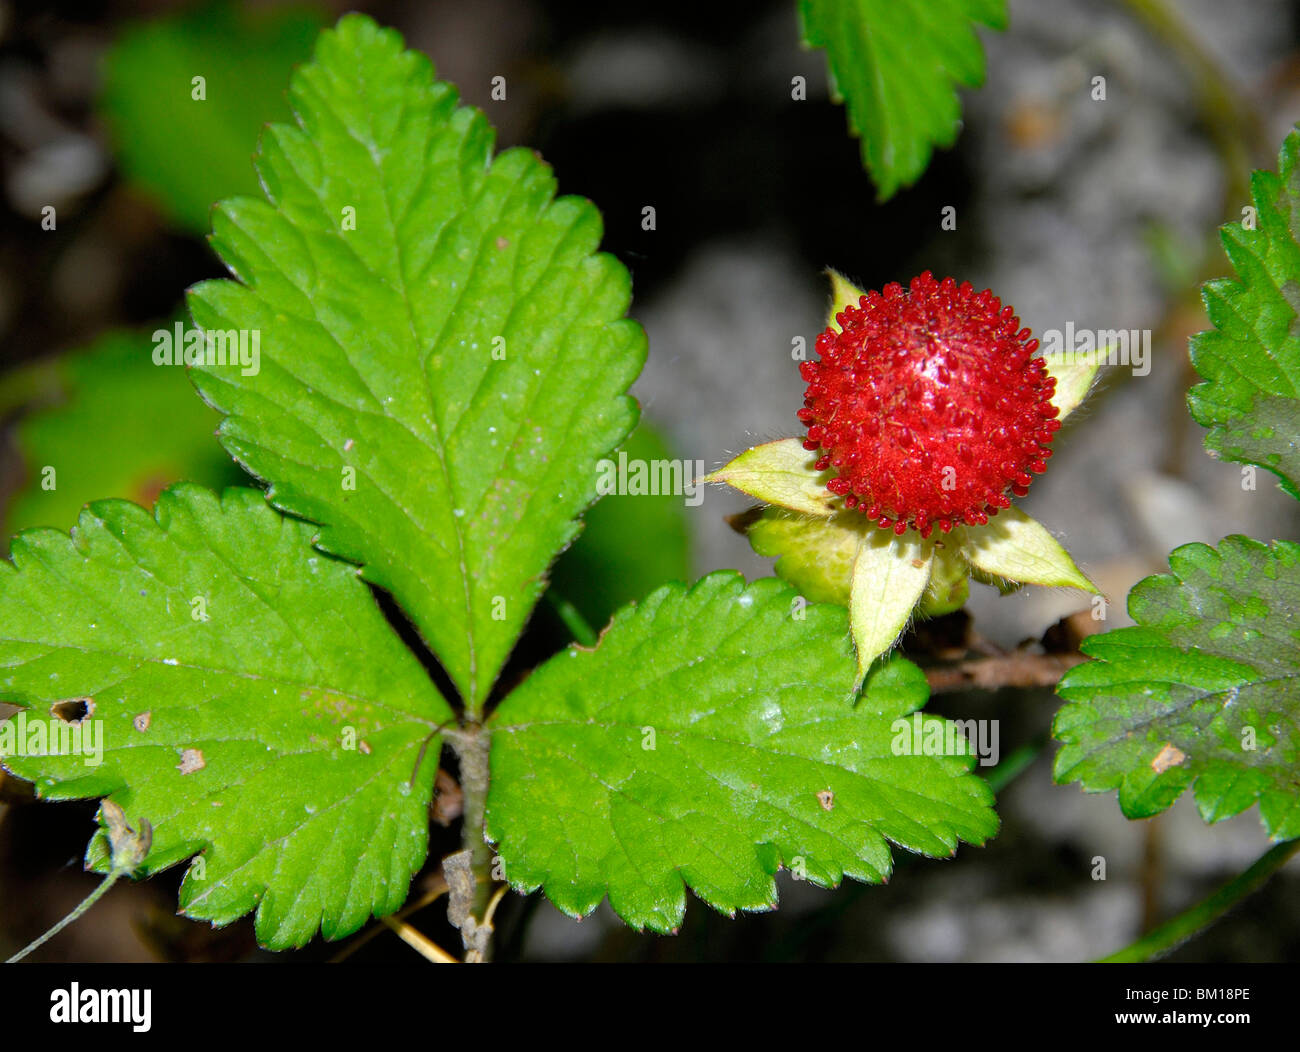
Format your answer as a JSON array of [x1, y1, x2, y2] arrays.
[[488, 572, 997, 931]]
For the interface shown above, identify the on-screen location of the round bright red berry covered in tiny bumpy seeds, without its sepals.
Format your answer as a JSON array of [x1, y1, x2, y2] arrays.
[[800, 270, 1061, 537]]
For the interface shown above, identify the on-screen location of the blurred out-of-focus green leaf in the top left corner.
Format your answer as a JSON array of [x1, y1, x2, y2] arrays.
[[99, 4, 321, 231]]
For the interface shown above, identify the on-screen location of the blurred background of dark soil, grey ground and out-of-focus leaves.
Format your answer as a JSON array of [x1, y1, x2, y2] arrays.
[[0, 0, 1300, 962]]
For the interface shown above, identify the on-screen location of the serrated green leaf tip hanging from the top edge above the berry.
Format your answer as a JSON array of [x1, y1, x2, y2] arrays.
[[800, 0, 1006, 200]]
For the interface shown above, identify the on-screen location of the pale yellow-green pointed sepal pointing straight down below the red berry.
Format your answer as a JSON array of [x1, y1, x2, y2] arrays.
[[849, 529, 935, 683]]
